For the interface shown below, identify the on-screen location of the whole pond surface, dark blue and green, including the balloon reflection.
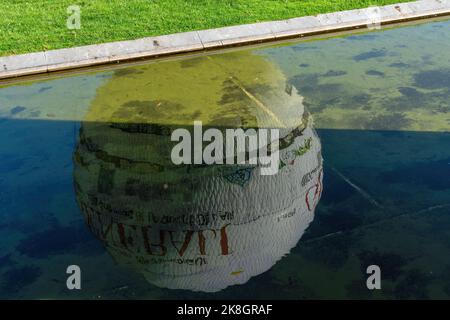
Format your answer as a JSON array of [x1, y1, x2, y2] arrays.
[[0, 20, 450, 299]]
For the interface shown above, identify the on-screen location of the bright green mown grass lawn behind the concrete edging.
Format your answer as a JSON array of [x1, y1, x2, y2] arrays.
[[0, 0, 414, 55]]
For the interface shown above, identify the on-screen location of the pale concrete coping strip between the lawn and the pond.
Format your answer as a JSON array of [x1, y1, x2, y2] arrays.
[[0, 0, 450, 79]]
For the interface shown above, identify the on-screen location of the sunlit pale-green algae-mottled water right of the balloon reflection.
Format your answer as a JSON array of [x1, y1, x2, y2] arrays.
[[259, 18, 450, 132]]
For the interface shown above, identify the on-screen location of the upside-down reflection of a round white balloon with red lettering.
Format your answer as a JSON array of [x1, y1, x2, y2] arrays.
[[74, 53, 322, 291]]
